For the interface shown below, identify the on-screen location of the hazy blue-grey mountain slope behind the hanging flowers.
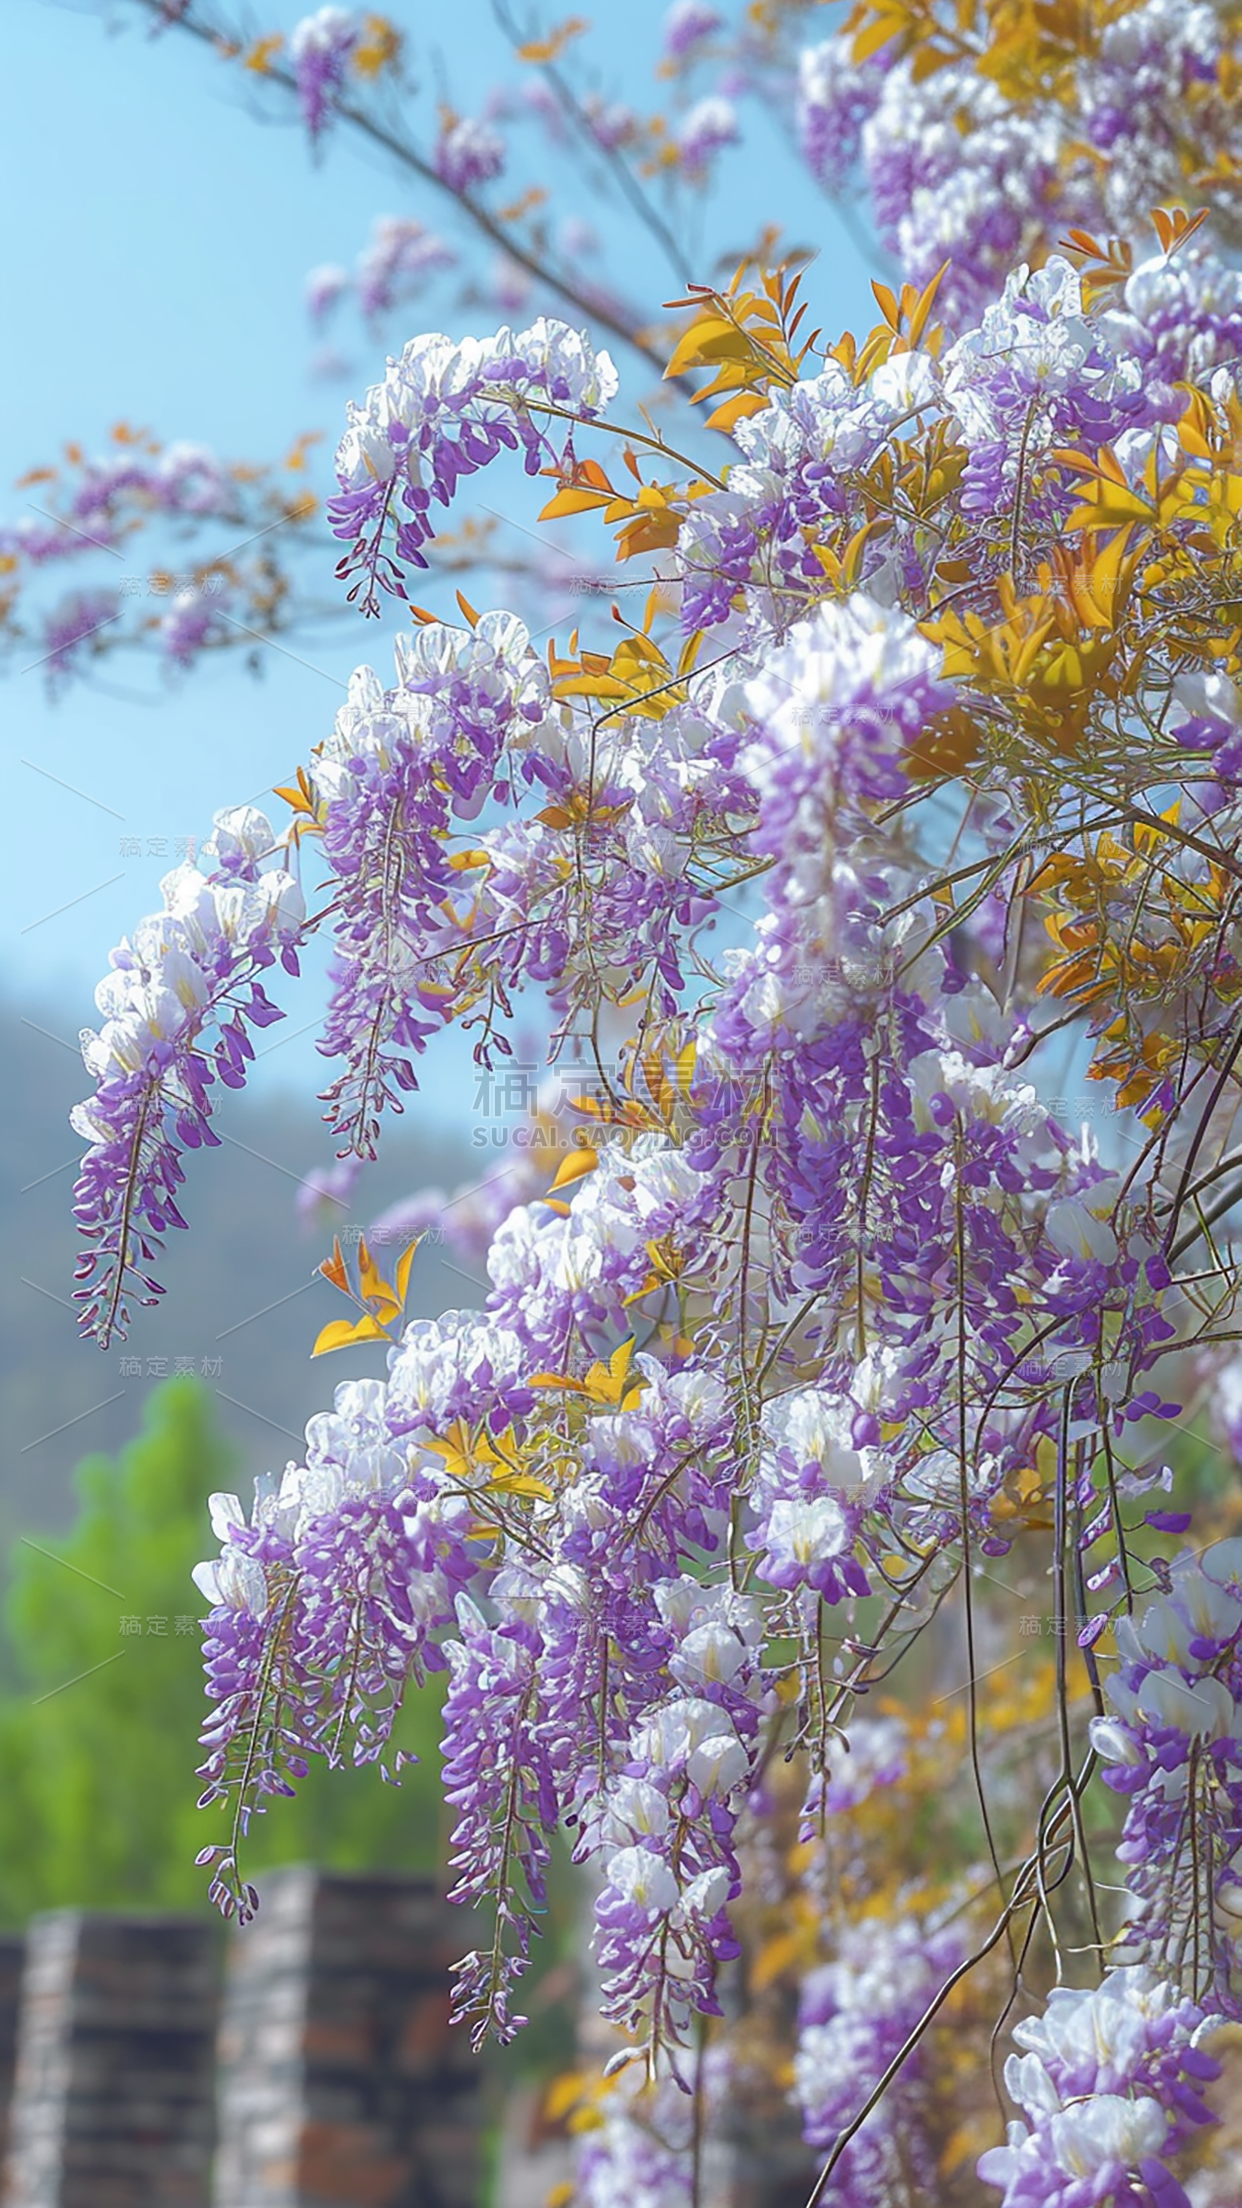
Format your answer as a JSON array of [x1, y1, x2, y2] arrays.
[[0, 1002, 486, 1548]]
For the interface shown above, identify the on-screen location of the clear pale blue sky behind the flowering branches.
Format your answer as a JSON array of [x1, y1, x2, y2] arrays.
[[0, 0, 871, 1104]]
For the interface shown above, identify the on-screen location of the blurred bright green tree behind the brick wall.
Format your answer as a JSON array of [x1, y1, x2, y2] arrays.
[[0, 1380, 442, 1923]]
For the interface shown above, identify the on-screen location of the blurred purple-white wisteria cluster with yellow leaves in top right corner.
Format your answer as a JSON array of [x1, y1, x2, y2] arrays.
[[798, 0, 1242, 327]]
